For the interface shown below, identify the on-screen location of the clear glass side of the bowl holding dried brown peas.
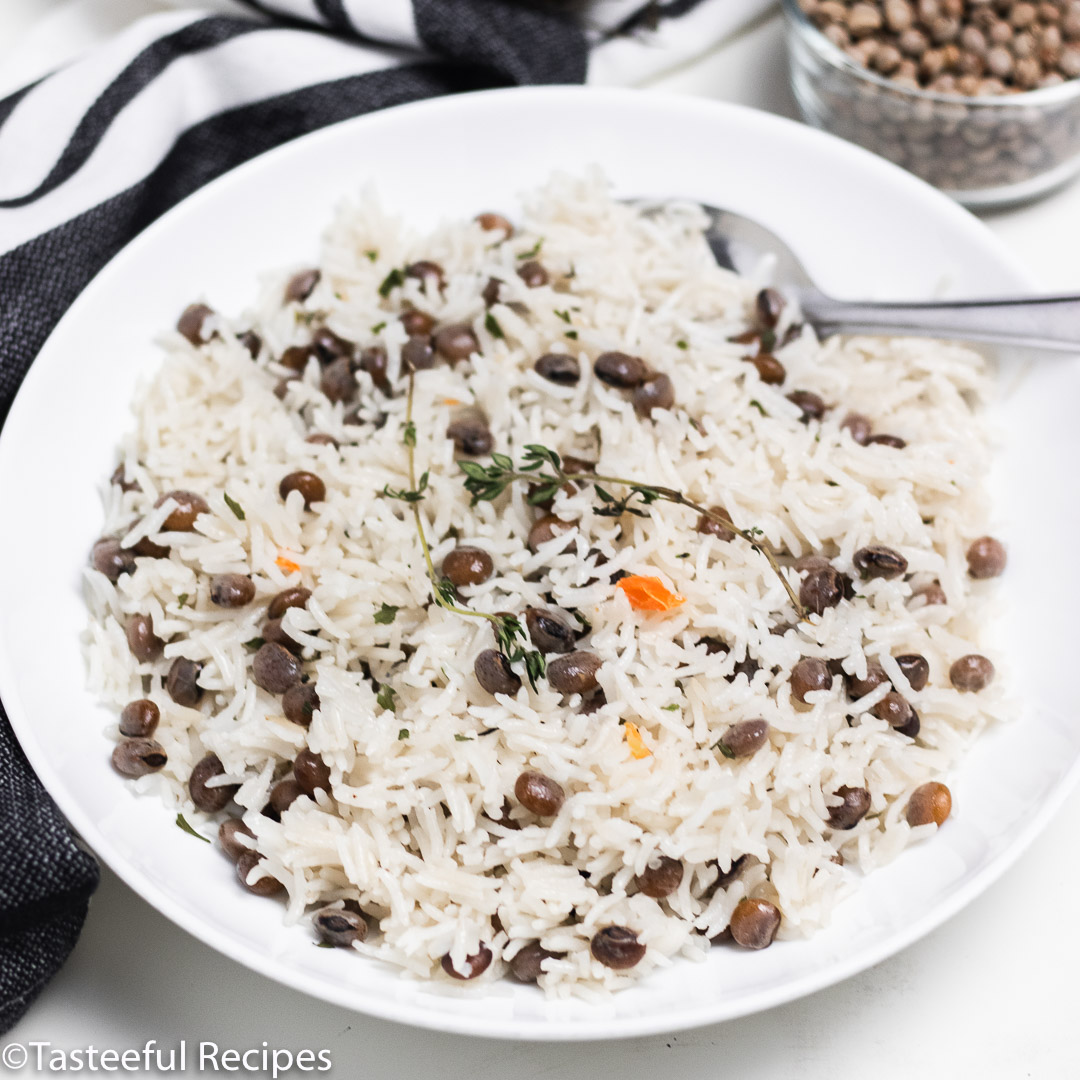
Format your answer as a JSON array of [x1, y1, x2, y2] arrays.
[[783, 0, 1080, 208]]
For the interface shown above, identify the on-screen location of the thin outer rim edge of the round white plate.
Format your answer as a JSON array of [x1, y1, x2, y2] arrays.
[[0, 79, 1080, 1042]]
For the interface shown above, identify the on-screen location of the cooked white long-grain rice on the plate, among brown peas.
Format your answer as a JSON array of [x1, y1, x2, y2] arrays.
[[86, 175, 1009, 996]]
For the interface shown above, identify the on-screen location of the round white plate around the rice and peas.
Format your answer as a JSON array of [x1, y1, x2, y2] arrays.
[[0, 87, 1080, 1039]]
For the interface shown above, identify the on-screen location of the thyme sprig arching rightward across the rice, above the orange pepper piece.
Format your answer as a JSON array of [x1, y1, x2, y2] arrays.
[[458, 443, 806, 619]]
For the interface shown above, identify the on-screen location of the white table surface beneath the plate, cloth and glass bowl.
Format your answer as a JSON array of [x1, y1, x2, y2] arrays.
[[0, 0, 1080, 1080]]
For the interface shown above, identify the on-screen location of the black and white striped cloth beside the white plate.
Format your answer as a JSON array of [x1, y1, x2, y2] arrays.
[[0, 0, 771, 1032]]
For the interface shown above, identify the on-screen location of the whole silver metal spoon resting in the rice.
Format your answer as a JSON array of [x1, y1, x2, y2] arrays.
[[702, 204, 1080, 352]]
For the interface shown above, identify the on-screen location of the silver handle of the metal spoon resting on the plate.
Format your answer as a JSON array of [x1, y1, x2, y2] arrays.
[[801, 291, 1080, 352]]
